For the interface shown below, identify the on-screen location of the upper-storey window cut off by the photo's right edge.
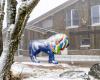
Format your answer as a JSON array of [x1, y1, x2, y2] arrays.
[[91, 5, 100, 25]]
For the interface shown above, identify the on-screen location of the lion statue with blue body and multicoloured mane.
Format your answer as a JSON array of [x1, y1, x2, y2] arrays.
[[29, 33, 69, 64]]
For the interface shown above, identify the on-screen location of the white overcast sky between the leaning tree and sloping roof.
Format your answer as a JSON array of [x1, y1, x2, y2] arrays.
[[29, 0, 68, 21]]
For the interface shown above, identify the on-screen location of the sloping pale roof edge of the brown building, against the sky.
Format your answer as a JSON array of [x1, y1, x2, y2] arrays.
[[26, 0, 78, 28]]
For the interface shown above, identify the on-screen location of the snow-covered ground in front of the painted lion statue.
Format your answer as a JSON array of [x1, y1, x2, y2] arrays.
[[11, 62, 94, 80]]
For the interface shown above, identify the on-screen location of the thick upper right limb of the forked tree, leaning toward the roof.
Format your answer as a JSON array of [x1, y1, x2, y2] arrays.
[[12, 0, 39, 39]]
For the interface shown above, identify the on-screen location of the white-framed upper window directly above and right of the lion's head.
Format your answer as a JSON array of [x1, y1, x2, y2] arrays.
[[66, 9, 79, 28]]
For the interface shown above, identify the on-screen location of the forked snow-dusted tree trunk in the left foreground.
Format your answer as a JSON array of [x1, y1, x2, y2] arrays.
[[0, 0, 39, 80]]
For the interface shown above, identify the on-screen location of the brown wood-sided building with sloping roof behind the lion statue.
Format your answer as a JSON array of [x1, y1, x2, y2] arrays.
[[2, 0, 100, 55]]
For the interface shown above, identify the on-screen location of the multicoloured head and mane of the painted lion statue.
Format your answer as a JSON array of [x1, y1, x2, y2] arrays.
[[49, 33, 69, 53]]
